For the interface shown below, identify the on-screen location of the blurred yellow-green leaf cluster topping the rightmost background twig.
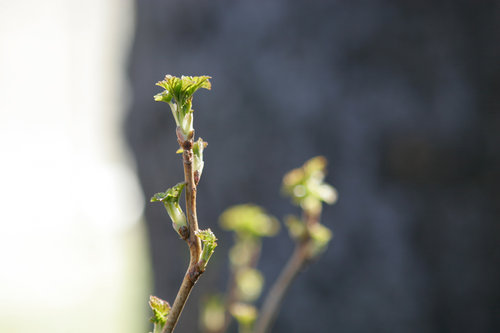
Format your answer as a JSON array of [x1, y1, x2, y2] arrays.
[[283, 156, 337, 214]]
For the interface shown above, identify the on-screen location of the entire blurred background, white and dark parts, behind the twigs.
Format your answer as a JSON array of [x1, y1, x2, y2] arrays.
[[0, 0, 500, 333]]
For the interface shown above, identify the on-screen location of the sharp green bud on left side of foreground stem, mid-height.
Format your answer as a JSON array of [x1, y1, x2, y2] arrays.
[[151, 182, 189, 239]]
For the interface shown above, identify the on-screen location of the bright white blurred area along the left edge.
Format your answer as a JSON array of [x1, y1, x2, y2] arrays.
[[0, 0, 150, 333]]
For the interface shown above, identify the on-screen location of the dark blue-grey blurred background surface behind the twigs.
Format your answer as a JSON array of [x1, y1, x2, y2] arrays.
[[126, 0, 500, 332]]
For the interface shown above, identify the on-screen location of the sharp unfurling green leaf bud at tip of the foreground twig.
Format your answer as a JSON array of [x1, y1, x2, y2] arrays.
[[154, 75, 212, 140]]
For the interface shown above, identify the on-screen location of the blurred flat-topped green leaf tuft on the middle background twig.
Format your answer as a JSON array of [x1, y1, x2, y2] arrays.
[[220, 204, 279, 237]]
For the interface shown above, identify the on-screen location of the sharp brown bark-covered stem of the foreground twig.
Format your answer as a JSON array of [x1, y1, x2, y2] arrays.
[[162, 139, 203, 333]]
